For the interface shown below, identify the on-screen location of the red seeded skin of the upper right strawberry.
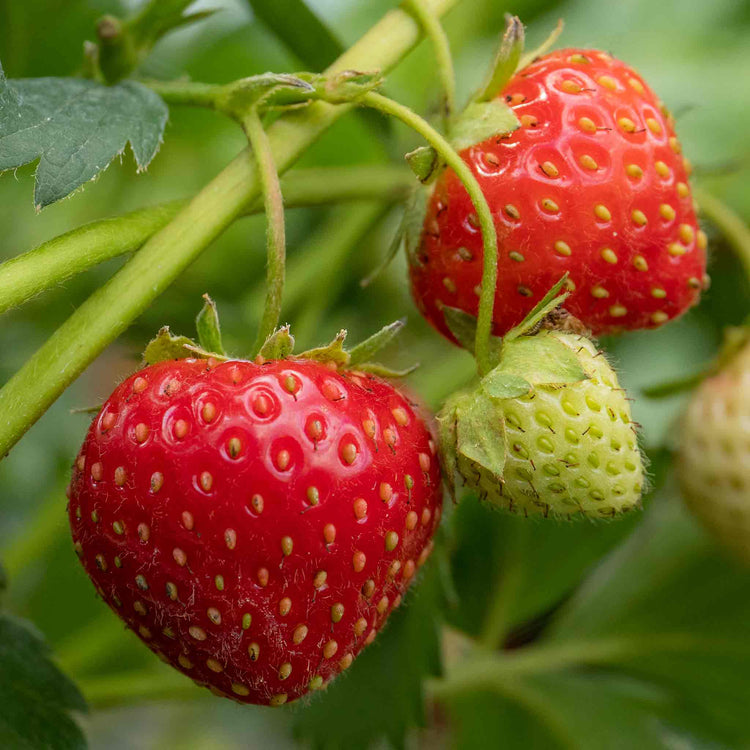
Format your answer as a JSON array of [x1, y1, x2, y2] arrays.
[[411, 49, 706, 341]]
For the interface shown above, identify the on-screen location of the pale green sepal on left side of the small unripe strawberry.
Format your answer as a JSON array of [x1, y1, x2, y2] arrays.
[[456, 397, 505, 479]]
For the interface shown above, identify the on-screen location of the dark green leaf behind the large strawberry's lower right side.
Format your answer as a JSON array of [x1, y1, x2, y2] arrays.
[[292, 544, 443, 750]]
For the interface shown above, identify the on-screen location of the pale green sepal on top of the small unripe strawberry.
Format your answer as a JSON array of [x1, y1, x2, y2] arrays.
[[497, 331, 587, 385]]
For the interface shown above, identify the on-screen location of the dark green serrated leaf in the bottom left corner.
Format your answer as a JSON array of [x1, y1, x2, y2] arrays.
[[0, 612, 86, 750]]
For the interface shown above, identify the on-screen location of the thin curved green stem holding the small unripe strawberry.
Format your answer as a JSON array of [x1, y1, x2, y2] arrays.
[[357, 92, 497, 375]]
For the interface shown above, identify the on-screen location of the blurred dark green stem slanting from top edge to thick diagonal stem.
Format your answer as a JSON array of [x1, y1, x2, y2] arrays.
[[249, 0, 344, 71]]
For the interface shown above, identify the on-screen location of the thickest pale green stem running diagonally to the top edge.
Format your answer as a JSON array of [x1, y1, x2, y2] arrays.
[[0, 0, 464, 456]]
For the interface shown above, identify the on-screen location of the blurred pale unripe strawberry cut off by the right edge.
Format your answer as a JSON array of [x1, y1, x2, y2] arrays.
[[677, 344, 750, 563]]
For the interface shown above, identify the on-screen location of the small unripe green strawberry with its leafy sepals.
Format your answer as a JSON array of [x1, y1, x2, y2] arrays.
[[439, 330, 644, 518]]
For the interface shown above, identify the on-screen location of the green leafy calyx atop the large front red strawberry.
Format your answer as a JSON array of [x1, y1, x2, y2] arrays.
[[143, 294, 418, 378]]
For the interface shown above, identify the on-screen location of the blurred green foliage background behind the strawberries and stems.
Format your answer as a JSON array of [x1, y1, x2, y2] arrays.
[[0, 0, 750, 750]]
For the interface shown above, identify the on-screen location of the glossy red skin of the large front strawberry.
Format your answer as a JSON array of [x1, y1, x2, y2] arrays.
[[68, 359, 442, 705]]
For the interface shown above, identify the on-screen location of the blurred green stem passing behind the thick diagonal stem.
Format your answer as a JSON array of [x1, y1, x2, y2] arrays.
[[0, 165, 414, 314]]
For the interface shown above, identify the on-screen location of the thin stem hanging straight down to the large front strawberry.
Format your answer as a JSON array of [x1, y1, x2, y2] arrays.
[[242, 109, 286, 357]]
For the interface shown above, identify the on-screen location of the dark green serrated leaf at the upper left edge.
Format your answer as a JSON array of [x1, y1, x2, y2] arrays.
[[0, 69, 168, 209]]
